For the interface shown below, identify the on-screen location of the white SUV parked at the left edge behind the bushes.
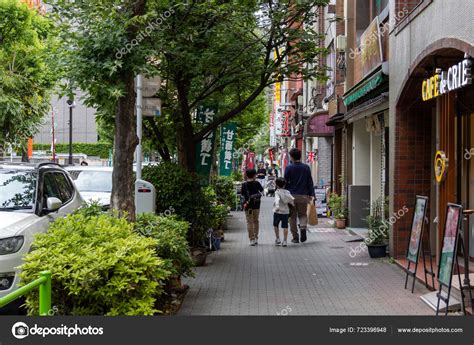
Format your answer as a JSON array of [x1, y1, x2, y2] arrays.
[[0, 162, 83, 304]]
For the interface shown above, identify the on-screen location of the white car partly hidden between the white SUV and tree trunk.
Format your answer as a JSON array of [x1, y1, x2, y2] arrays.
[[66, 166, 113, 208]]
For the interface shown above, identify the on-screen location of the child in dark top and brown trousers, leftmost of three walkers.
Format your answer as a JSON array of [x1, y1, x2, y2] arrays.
[[242, 169, 263, 246]]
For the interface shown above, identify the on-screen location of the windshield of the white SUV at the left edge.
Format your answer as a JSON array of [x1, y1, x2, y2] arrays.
[[0, 169, 36, 211]]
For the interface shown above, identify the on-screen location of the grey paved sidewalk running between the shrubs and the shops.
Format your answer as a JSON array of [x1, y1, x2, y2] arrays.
[[179, 197, 433, 315]]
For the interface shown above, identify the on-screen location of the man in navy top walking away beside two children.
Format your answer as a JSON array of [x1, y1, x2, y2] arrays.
[[285, 148, 315, 243]]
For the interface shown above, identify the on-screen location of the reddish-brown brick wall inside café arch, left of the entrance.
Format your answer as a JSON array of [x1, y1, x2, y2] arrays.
[[393, 104, 433, 257]]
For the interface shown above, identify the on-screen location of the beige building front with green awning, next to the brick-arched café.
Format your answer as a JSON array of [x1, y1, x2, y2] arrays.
[[328, 0, 389, 228]]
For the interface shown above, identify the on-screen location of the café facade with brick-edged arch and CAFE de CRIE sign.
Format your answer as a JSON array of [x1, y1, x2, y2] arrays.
[[389, 0, 474, 260]]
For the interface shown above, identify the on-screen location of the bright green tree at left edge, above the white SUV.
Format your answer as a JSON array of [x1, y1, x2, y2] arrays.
[[0, 0, 56, 151]]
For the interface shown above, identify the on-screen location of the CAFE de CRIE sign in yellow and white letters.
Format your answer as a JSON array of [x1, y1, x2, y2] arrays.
[[421, 54, 472, 101]]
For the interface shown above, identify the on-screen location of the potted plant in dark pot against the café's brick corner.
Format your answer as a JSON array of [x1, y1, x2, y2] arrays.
[[365, 198, 388, 258]]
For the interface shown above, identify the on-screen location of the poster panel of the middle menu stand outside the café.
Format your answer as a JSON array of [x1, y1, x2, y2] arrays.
[[438, 204, 462, 286]]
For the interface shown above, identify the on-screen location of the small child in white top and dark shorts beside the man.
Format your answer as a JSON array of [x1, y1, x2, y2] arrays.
[[273, 177, 295, 247]]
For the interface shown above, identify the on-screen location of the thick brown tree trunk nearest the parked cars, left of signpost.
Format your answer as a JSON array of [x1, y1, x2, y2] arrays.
[[111, 75, 138, 221]]
